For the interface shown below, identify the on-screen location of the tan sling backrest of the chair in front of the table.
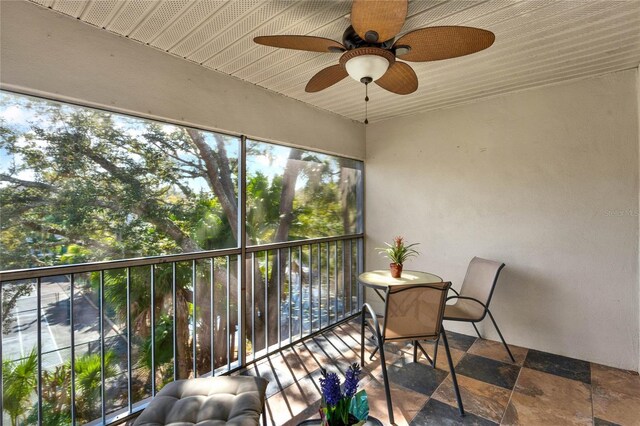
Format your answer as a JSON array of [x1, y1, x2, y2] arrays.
[[382, 282, 451, 340]]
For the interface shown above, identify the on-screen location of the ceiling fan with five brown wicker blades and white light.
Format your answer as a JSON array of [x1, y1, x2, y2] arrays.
[[253, 0, 495, 100]]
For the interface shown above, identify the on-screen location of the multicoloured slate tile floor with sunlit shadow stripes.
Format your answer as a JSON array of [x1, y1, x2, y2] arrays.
[[240, 322, 640, 426]]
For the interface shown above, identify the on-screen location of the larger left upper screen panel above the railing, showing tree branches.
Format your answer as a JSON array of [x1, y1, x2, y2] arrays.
[[0, 93, 240, 270]]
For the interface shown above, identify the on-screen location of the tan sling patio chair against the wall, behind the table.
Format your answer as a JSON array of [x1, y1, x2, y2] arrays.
[[434, 257, 516, 362]]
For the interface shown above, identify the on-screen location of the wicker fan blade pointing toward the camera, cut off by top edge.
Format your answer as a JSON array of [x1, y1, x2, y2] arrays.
[[351, 0, 408, 43]]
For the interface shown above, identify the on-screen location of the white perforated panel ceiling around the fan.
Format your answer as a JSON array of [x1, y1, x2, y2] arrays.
[[25, 0, 640, 121]]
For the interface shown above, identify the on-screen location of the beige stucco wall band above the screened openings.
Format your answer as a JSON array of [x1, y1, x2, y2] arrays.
[[0, 1, 365, 159]]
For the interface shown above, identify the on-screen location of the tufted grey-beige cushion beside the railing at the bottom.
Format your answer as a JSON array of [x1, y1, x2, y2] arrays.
[[134, 376, 268, 426]]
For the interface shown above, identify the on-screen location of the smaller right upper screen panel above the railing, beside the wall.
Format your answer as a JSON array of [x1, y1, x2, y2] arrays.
[[246, 140, 362, 245]]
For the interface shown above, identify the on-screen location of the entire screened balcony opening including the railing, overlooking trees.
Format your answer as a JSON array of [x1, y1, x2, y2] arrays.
[[0, 92, 363, 424]]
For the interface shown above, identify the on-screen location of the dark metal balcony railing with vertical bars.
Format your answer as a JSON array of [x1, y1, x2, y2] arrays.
[[0, 234, 363, 424]]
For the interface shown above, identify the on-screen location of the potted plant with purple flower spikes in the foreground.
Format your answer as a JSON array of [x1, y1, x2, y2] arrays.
[[320, 363, 369, 426]]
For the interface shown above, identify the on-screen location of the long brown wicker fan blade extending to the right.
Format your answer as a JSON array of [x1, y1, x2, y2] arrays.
[[394, 27, 496, 62]]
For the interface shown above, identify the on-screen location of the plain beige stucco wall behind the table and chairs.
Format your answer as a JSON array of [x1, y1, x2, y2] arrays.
[[366, 69, 639, 370]]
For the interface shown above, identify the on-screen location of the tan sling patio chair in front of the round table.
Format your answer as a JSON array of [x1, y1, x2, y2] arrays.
[[360, 282, 464, 424]]
